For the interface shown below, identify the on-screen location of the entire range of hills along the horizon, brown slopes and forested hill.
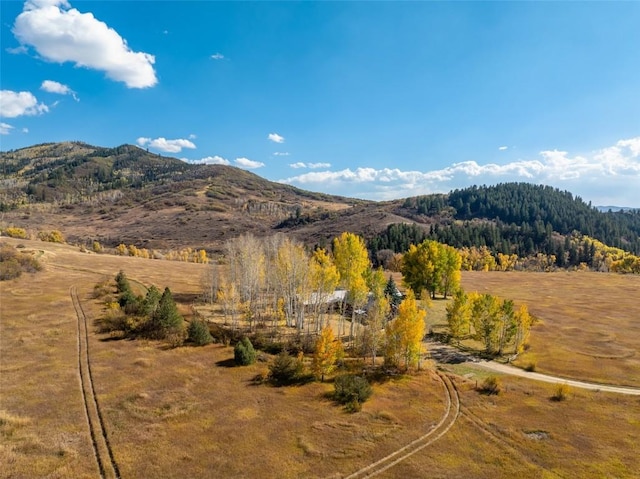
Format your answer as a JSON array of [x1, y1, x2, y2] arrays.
[[0, 142, 640, 266]]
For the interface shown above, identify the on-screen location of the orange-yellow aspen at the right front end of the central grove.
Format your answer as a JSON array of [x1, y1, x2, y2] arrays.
[[385, 290, 426, 369]]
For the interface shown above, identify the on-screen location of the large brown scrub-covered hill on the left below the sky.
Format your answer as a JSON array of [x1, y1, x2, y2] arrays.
[[0, 142, 366, 250]]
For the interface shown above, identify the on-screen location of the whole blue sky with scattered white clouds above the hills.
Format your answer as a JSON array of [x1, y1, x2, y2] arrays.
[[0, 0, 640, 207]]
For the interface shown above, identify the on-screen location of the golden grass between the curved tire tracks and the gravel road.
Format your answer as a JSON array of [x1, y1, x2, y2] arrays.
[[380, 376, 640, 479]]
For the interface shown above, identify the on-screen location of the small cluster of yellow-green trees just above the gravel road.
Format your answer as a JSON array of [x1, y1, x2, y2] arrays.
[[447, 289, 533, 354]]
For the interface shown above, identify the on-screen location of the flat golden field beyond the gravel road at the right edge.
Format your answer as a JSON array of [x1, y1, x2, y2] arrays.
[[462, 272, 640, 386]]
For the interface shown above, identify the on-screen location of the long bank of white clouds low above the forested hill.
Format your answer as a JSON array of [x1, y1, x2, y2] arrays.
[[281, 137, 640, 207]]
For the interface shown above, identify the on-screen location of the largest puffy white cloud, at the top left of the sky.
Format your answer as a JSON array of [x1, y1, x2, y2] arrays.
[[13, 0, 158, 88]]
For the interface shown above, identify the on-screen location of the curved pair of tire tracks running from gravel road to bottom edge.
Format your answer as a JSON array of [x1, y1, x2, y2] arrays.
[[345, 371, 460, 479]]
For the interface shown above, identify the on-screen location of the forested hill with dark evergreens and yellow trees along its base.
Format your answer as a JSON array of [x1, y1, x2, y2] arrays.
[[369, 183, 640, 269]]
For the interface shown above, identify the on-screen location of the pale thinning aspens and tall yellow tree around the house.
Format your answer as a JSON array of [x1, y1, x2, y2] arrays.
[[209, 233, 358, 334]]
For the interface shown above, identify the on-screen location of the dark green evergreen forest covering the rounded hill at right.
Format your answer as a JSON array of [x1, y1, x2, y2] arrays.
[[398, 183, 640, 257]]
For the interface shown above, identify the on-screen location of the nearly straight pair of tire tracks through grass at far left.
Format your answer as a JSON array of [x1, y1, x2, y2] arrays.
[[69, 286, 121, 479]]
